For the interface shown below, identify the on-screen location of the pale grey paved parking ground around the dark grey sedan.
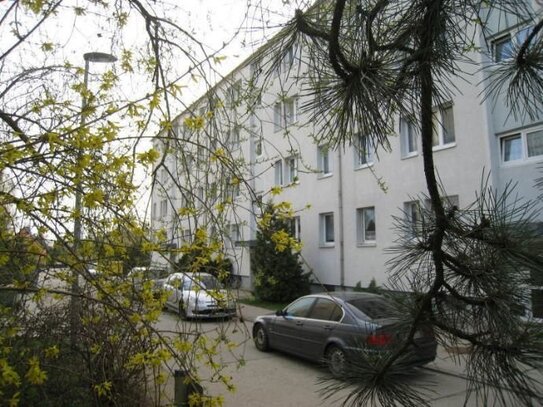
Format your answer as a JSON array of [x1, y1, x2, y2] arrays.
[[156, 304, 540, 407]]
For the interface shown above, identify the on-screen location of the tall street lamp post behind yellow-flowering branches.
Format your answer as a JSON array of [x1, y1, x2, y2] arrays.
[[70, 52, 117, 346]]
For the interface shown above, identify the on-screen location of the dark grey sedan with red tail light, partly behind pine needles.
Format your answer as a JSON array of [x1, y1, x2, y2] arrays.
[[253, 292, 437, 377]]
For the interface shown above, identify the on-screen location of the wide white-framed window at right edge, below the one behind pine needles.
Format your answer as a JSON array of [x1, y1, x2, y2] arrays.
[[500, 128, 543, 163]]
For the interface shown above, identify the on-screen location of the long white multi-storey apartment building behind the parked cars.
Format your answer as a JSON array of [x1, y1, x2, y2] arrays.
[[152, 2, 543, 317]]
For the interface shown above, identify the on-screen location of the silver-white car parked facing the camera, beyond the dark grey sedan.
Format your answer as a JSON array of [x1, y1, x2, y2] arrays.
[[162, 273, 236, 318]]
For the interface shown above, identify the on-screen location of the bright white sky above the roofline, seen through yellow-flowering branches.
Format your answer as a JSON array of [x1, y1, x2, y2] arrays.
[[0, 0, 306, 230]]
